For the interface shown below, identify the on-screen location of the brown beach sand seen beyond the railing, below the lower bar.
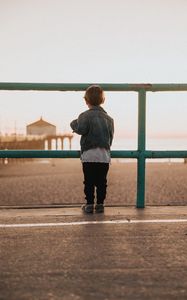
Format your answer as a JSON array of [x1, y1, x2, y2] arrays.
[[0, 159, 187, 206]]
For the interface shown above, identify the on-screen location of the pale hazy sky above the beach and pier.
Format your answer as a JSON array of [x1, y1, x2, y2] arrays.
[[0, 0, 187, 146]]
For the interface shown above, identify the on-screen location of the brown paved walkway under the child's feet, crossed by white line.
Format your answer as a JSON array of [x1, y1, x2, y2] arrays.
[[0, 206, 187, 300]]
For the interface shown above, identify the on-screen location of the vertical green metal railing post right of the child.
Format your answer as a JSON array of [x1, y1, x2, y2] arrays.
[[136, 89, 146, 208]]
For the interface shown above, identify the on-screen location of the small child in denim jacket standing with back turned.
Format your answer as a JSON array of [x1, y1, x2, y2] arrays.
[[70, 85, 114, 213]]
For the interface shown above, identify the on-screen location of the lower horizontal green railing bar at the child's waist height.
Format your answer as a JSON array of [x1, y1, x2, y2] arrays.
[[0, 150, 187, 158]]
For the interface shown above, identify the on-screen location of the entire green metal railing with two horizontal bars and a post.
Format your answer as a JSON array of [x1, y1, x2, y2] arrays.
[[0, 82, 187, 208]]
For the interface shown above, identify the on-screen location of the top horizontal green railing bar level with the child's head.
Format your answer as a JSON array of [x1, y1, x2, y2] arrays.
[[0, 82, 187, 92]]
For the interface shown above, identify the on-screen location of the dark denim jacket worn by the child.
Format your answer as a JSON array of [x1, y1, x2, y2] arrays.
[[70, 106, 114, 152]]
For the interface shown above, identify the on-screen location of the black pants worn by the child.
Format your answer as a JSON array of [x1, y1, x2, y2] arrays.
[[82, 162, 109, 204]]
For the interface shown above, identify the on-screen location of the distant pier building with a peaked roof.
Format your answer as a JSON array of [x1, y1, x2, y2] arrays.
[[26, 117, 56, 136]]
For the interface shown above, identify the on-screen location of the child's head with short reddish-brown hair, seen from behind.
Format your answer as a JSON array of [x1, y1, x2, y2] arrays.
[[84, 85, 105, 106]]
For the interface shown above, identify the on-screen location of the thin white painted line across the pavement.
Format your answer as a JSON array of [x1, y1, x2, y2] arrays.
[[0, 219, 187, 228]]
